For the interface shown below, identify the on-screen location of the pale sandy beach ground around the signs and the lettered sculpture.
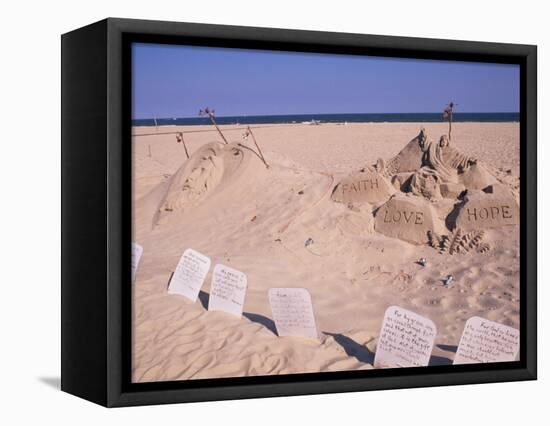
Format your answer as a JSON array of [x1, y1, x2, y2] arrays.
[[132, 122, 519, 382]]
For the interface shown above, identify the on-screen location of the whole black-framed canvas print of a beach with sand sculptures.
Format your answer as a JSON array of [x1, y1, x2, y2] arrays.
[[62, 19, 536, 406]]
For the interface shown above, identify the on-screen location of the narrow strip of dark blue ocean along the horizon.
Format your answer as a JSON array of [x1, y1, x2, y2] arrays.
[[132, 112, 519, 126]]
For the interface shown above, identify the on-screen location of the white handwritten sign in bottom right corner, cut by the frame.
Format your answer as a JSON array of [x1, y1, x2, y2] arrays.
[[453, 317, 519, 364]]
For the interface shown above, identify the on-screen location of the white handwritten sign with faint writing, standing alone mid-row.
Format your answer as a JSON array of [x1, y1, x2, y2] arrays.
[[269, 288, 319, 339]]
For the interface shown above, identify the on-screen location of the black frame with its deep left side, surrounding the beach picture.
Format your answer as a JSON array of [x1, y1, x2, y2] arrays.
[[61, 18, 537, 407]]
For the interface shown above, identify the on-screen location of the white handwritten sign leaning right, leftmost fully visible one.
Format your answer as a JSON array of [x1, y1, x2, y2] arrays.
[[168, 249, 210, 302]]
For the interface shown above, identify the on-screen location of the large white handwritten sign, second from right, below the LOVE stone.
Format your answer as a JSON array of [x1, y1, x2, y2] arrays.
[[374, 306, 437, 367]]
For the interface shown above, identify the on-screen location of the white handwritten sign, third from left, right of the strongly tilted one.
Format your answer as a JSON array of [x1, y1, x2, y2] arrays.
[[208, 264, 247, 317]]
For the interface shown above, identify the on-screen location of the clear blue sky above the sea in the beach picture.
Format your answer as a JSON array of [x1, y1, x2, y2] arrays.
[[132, 44, 519, 119]]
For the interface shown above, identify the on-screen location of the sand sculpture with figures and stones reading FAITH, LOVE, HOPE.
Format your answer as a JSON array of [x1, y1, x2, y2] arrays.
[[332, 128, 519, 248]]
